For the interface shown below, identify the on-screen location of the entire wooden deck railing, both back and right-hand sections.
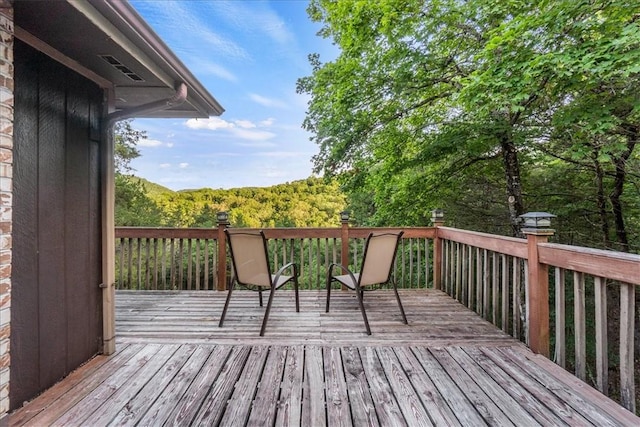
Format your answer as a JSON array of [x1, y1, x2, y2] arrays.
[[116, 222, 640, 411]]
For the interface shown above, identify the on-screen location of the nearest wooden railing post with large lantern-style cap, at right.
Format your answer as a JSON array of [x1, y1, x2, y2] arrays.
[[520, 212, 555, 358]]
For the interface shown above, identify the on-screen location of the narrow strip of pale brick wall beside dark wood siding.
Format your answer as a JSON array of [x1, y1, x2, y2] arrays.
[[0, 0, 13, 423]]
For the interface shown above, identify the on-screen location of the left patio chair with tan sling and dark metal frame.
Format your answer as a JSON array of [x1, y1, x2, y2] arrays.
[[218, 229, 300, 336]]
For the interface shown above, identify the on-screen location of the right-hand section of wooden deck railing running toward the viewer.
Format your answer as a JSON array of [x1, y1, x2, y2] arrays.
[[435, 227, 640, 412]]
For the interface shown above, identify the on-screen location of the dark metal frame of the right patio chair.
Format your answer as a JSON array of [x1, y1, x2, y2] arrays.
[[325, 231, 408, 335]]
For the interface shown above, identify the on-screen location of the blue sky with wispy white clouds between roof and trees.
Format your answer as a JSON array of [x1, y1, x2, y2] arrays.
[[130, 0, 338, 190]]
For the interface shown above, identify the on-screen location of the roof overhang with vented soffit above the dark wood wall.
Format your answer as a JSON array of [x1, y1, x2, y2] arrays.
[[14, 0, 224, 118]]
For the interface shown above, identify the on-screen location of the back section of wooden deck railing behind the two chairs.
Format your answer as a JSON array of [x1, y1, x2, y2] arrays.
[[116, 224, 435, 290]]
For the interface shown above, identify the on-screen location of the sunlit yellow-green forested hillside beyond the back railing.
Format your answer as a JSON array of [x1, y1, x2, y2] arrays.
[[116, 177, 345, 228]]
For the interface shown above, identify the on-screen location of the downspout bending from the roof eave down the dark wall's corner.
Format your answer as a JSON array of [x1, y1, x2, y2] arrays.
[[100, 83, 187, 355]]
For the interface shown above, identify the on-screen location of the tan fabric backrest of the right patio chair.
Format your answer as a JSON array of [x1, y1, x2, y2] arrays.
[[360, 231, 404, 286]]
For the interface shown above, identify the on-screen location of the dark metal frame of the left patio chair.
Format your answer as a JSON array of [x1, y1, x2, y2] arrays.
[[218, 229, 300, 336]]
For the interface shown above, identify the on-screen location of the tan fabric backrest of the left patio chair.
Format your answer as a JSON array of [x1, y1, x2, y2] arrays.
[[224, 229, 271, 287]]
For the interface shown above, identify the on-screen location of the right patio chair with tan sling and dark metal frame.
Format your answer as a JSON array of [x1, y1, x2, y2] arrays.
[[326, 231, 407, 335]]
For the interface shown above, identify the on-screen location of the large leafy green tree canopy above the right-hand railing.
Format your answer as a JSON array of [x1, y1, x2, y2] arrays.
[[298, 0, 640, 250]]
